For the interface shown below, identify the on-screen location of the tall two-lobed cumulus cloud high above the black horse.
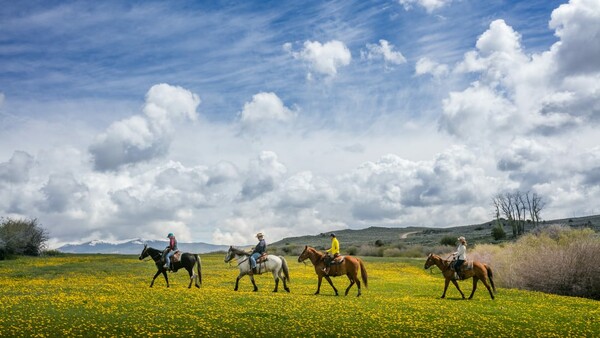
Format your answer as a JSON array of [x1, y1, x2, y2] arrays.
[[89, 84, 200, 171]]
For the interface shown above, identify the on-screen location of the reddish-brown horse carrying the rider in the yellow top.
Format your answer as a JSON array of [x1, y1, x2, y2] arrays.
[[298, 246, 367, 297]]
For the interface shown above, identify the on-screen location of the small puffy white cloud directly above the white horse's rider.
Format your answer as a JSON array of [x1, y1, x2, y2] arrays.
[[240, 92, 296, 127]]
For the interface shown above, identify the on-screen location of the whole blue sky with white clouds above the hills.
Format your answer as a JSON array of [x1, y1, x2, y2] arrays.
[[0, 0, 600, 247]]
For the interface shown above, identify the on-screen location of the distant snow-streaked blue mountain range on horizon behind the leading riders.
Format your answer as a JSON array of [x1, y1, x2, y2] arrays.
[[57, 238, 229, 255]]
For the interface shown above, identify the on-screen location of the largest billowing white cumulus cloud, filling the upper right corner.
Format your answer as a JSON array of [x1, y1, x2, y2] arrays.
[[440, 1, 600, 140]]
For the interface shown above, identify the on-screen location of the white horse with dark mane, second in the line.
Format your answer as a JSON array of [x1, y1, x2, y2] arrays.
[[225, 246, 290, 292]]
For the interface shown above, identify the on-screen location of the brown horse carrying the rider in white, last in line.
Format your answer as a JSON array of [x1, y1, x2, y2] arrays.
[[425, 254, 496, 299]]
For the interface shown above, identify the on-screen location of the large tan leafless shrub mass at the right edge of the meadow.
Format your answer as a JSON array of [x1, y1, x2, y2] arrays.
[[473, 226, 600, 299]]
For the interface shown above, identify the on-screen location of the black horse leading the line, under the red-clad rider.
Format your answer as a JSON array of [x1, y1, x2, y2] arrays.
[[139, 244, 202, 289]]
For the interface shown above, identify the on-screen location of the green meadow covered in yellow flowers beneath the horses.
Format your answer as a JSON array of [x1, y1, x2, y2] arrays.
[[0, 254, 600, 337]]
